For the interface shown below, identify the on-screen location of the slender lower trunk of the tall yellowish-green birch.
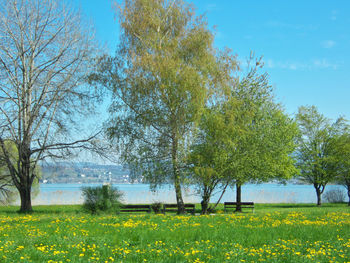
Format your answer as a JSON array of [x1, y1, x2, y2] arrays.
[[171, 135, 185, 214]]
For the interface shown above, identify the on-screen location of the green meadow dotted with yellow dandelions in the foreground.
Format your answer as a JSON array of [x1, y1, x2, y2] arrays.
[[0, 204, 350, 263]]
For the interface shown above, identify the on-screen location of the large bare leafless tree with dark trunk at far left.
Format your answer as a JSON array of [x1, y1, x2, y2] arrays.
[[0, 0, 96, 212]]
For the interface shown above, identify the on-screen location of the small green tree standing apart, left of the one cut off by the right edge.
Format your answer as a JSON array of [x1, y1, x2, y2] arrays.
[[296, 106, 344, 206]]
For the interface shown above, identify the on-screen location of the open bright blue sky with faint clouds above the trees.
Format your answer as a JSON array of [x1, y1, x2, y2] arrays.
[[72, 0, 350, 120]]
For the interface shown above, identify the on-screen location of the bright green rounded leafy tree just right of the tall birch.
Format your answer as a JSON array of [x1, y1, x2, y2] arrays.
[[189, 60, 297, 214]]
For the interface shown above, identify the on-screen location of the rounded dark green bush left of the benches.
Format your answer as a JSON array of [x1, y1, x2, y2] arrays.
[[82, 185, 123, 214]]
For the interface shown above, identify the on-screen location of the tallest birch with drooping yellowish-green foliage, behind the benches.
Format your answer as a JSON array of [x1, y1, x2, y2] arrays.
[[91, 0, 234, 213]]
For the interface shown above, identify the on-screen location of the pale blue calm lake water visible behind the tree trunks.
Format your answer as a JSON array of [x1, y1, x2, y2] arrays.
[[26, 184, 344, 205]]
